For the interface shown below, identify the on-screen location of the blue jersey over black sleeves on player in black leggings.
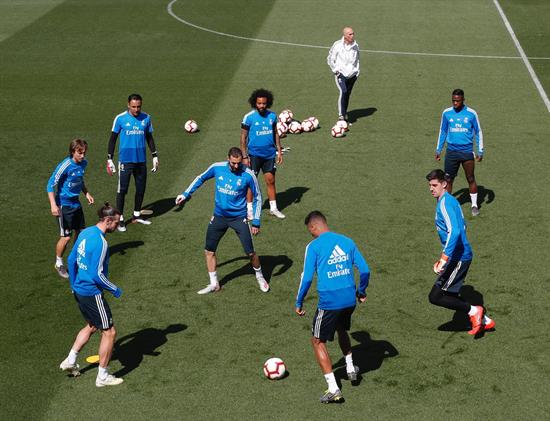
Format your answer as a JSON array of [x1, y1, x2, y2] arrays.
[[111, 111, 153, 163]]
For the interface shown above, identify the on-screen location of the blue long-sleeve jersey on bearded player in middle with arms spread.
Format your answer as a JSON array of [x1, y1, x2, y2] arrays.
[[182, 161, 262, 227]]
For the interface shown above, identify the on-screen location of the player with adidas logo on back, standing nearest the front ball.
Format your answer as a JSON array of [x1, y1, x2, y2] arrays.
[[295, 211, 370, 403]]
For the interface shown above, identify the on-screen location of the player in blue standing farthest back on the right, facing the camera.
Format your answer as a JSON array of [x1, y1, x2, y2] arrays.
[[435, 89, 483, 216]]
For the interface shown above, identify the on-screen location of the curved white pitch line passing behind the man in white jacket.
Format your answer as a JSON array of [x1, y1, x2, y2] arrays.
[[166, 0, 550, 60]]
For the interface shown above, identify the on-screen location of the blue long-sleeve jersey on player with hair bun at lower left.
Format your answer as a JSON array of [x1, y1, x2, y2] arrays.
[[68, 225, 122, 297]]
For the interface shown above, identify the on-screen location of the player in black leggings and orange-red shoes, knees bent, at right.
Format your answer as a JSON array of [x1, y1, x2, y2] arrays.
[[426, 169, 495, 335]]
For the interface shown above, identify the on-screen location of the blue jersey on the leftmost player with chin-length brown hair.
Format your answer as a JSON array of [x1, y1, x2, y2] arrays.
[[46, 156, 88, 208]]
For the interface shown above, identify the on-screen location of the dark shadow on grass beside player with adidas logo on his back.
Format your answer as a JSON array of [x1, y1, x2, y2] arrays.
[[334, 331, 399, 386]]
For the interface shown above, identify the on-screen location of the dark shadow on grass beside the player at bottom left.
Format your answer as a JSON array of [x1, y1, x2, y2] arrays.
[[112, 323, 187, 377]]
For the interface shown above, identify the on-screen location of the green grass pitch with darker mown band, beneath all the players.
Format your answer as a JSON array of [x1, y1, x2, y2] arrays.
[[0, 0, 550, 419]]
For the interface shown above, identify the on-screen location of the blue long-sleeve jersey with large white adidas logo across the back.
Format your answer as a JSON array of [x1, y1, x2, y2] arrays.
[[296, 231, 370, 310]]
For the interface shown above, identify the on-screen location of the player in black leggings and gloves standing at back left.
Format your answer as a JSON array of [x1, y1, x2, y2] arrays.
[[107, 94, 159, 231]]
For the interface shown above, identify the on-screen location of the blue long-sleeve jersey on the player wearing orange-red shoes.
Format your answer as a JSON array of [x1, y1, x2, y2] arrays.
[[435, 192, 473, 260]]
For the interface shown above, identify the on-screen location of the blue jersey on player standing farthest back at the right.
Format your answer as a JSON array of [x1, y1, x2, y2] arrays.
[[436, 105, 483, 156]]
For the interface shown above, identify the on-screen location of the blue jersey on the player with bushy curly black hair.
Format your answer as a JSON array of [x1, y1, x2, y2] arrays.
[[241, 109, 277, 159]]
